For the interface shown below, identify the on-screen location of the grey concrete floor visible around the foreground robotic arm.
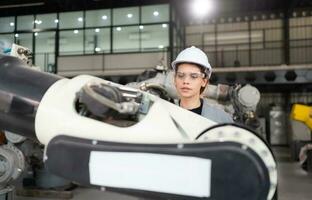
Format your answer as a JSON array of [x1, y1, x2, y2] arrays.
[[15, 147, 312, 200]]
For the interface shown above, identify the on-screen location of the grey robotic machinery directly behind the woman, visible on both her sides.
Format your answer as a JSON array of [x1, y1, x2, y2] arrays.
[[127, 65, 260, 129]]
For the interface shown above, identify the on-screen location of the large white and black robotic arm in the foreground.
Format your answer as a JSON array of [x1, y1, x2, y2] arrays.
[[0, 56, 277, 200]]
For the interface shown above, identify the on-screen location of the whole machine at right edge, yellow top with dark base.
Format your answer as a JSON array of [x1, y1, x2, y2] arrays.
[[290, 104, 312, 172]]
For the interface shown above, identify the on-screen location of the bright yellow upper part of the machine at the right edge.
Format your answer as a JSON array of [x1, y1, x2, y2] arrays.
[[290, 104, 312, 130]]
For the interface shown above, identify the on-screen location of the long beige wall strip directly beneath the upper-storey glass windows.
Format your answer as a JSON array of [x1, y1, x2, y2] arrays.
[[58, 52, 168, 76]]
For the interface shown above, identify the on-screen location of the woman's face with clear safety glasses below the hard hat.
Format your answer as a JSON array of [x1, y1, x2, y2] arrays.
[[174, 63, 208, 98]]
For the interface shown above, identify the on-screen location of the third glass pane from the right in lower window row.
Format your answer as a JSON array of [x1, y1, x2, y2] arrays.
[[85, 28, 110, 54]]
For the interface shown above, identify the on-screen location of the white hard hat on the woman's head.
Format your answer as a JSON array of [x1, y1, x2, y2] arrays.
[[171, 46, 211, 79]]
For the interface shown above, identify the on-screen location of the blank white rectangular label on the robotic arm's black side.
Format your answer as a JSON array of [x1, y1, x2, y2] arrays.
[[89, 151, 211, 197]]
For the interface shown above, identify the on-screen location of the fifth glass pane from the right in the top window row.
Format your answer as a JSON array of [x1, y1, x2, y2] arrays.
[[34, 13, 58, 29]]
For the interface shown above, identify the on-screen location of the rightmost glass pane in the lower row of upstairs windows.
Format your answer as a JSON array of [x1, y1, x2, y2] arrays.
[[140, 24, 169, 51]]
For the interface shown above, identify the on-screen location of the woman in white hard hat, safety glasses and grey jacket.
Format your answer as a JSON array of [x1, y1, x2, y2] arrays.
[[172, 46, 233, 123]]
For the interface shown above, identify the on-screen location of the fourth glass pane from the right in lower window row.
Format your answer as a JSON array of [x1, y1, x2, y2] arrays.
[[59, 29, 83, 55]]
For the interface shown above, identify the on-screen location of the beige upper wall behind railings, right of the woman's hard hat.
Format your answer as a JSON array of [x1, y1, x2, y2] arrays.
[[186, 14, 312, 67]]
